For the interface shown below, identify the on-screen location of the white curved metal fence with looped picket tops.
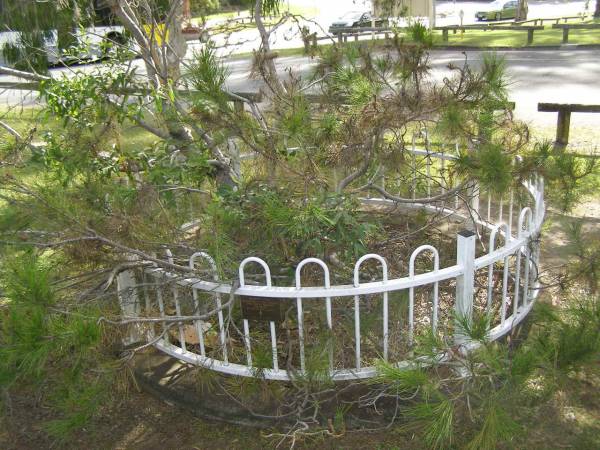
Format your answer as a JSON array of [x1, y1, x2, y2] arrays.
[[119, 146, 545, 380]]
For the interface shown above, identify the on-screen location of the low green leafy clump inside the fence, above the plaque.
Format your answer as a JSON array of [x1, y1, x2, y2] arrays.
[[202, 185, 378, 274]]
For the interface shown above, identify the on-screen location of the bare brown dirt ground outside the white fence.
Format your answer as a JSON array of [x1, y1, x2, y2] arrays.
[[0, 158, 600, 450]]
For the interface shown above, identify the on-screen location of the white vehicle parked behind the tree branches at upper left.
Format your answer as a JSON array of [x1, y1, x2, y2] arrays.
[[0, 26, 134, 66]]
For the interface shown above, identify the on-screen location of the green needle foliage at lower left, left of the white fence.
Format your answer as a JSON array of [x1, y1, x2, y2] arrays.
[[0, 252, 118, 440]]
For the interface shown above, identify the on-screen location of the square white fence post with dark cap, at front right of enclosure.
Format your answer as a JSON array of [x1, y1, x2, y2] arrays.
[[454, 230, 476, 345]]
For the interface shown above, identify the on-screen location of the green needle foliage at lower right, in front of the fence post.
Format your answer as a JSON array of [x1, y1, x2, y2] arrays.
[[371, 297, 600, 450]]
